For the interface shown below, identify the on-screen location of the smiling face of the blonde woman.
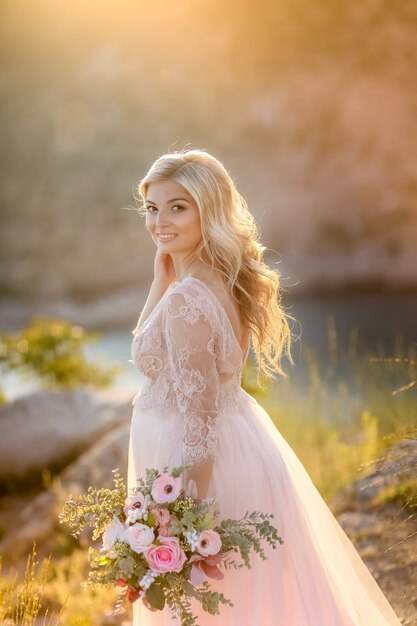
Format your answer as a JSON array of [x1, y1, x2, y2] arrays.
[[145, 180, 202, 256]]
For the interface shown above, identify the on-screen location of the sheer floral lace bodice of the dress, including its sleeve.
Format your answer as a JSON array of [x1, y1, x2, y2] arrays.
[[131, 276, 249, 465]]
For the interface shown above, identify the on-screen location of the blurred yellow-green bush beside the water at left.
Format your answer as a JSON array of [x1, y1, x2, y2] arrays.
[[0, 318, 121, 389]]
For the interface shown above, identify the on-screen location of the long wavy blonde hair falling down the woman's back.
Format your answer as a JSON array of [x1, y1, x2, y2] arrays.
[[138, 149, 297, 381]]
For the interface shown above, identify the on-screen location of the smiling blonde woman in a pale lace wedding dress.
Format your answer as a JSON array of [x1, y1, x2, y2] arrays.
[[129, 150, 400, 626]]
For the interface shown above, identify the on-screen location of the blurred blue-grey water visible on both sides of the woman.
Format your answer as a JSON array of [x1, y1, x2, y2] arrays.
[[3, 294, 417, 399]]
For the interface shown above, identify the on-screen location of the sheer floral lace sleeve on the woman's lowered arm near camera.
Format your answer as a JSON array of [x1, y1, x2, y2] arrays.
[[165, 293, 219, 466]]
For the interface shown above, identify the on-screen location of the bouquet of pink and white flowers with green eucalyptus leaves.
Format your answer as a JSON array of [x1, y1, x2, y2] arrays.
[[59, 465, 283, 626]]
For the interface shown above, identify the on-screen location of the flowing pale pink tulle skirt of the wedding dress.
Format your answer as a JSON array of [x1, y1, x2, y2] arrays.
[[128, 389, 401, 626]]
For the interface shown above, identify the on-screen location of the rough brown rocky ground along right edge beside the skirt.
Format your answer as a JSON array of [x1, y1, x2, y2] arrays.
[[331, 439, 417, 626]]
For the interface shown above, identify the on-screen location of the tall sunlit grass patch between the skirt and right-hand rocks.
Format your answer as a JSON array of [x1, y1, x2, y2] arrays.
[[244, 320, 417, 500]]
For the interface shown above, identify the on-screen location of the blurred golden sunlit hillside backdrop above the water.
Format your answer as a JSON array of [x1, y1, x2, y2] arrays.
[[0, 0, 417, 328]]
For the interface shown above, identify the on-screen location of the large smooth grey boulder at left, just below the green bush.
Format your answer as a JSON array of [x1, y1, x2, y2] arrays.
[[0, 389, 132, 482]]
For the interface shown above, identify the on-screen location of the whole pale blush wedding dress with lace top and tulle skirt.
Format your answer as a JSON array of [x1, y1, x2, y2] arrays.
[[128, 276, 401, 626]]
